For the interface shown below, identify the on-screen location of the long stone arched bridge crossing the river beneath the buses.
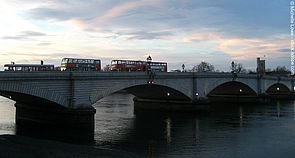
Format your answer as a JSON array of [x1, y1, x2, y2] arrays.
[[0, 71, 295, 129]]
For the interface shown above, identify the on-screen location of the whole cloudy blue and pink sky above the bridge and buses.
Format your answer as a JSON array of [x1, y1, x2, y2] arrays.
[[0, 0, 290, 71]]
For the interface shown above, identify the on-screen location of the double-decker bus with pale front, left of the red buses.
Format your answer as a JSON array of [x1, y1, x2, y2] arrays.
[[60, 58, 101, 71]]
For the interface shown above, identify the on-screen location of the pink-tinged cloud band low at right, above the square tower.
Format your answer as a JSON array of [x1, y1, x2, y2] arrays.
[[183, 32, 290, 60]]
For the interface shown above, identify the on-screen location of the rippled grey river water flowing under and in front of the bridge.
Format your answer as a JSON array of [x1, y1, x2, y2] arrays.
[[0, 94, 295, 158]]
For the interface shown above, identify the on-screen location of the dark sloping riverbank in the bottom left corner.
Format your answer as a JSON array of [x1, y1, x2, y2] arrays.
[[0, 135, 136, 158]]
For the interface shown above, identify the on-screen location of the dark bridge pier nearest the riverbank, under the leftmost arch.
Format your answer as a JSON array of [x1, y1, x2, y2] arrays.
[[15, 102, 95, 142]]
